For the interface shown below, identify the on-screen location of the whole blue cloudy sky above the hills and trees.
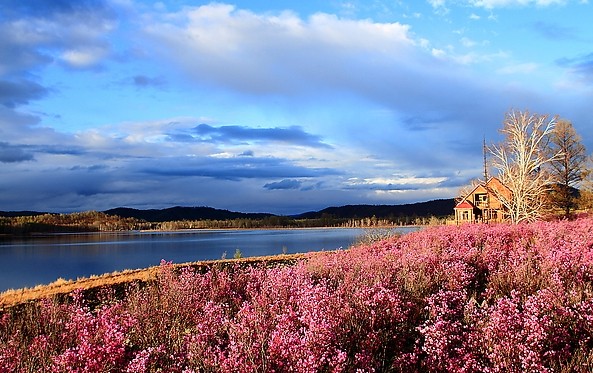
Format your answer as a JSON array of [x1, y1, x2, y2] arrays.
[[0, 0, 593, 215]]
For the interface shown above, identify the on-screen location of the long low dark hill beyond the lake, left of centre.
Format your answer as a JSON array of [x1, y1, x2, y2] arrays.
[[103, 206, 274, 223]]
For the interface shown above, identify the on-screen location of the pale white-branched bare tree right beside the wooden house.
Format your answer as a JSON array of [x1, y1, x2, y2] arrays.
[[489, 110, 557, 223]]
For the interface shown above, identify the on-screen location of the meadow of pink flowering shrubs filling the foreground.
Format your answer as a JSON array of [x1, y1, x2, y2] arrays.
[[0, 218, 593, 373]]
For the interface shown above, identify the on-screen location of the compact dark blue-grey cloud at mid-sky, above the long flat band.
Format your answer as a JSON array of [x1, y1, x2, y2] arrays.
[[194, 124, 332, 149]]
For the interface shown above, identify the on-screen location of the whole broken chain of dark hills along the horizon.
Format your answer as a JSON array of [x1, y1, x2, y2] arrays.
[[0, 198, 455, 223]]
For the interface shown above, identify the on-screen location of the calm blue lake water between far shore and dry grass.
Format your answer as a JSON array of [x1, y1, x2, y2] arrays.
[[0, 228, 414, 291]]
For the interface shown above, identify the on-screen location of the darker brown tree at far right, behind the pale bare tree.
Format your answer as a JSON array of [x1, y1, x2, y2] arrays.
[[548, 120, 587, 218]]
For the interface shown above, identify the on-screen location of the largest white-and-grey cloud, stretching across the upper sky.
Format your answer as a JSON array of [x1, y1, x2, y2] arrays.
[[140, 4, 506, 120]]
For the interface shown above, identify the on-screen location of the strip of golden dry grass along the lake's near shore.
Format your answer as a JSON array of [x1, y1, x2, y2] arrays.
[[0, 254, 305, 311]]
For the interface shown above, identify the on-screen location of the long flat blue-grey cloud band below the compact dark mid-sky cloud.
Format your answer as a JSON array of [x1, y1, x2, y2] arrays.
[[139, 157, 338, 180]]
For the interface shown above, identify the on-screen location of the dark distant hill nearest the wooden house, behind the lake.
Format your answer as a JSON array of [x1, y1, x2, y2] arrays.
[[295, 198, 455, 219]]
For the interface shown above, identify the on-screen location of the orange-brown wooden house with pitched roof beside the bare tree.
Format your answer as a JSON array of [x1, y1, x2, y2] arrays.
[[454, 177, 512, 224]]
